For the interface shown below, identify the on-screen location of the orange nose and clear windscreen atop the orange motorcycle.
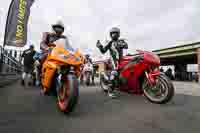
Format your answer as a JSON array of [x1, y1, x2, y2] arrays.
[[51, 39, 82, 65]]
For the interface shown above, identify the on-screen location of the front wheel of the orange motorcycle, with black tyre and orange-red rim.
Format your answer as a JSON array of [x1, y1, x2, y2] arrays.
[[56, 74, 79, 114]]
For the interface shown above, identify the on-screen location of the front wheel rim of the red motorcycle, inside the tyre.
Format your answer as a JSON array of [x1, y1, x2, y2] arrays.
[[143, 78, 169, 102]]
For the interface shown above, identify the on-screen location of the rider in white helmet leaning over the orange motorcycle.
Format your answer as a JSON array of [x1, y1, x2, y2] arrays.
[[40, 20, 66, 64]]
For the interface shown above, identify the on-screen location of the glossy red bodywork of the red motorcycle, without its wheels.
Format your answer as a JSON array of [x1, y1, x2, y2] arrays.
[[119, 50, 160, 95]]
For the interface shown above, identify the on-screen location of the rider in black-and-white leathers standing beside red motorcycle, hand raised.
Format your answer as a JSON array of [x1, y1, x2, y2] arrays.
[[97, 27, 128, 97]]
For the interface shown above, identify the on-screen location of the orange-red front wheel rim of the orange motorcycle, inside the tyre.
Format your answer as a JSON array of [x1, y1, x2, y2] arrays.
[[58, 81, 69, 111]]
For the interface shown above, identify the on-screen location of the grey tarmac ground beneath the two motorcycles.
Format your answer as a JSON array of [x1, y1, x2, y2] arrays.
[[0, 82, 200, 133]]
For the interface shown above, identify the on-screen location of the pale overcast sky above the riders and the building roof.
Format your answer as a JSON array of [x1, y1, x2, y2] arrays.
[[0, 0, 200, 54]]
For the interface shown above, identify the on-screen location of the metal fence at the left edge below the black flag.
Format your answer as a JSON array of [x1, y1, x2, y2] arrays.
[[0, 46, 22, 75]]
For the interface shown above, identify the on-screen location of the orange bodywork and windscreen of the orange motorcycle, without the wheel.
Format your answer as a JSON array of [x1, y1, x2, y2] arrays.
[[42, 39, 83, 89]]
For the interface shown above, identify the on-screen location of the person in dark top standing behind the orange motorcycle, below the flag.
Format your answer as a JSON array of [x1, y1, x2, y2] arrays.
[[21, 45, 36, 85]]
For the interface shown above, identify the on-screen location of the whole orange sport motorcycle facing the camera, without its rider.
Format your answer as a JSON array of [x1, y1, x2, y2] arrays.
[[41, 39, 83, 113]]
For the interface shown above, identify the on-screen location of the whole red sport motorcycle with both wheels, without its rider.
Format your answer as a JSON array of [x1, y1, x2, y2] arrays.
[[100, 50, 174, 104]]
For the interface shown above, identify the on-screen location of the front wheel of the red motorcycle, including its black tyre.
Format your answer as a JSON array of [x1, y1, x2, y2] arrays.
[[142, 74, 174, 104]]
